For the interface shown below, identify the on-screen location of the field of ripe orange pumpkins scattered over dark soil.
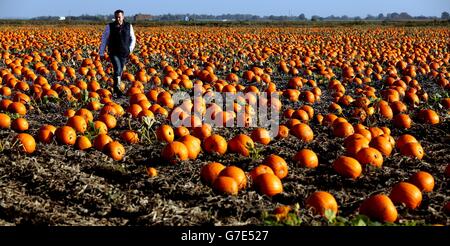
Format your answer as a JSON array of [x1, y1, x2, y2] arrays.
[[0, 24, 450, 226]]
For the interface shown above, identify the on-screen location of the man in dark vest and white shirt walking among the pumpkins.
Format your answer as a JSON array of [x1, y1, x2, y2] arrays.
[[100, 9, 136, 97]]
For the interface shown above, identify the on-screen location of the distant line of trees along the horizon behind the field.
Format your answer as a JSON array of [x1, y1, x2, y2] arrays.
[[33, 12, 450, 21]]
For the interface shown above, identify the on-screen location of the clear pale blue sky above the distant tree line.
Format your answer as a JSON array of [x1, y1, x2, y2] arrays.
[[0, 0, 450, 18]]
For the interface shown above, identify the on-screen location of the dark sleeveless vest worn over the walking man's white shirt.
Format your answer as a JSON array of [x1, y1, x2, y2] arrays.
[[108, 22, 131, 57]]
